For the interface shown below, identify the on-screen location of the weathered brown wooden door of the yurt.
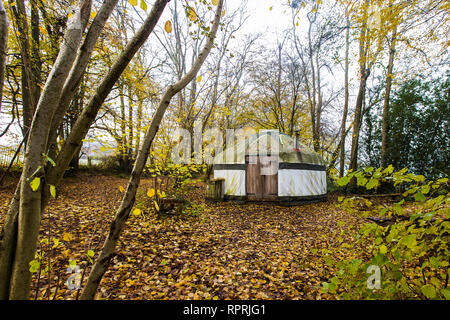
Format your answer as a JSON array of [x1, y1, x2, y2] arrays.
[[245, 156, 278, 198]]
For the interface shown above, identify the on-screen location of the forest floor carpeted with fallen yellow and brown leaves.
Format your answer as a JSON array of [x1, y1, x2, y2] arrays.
[[0, 172, 367, 299]]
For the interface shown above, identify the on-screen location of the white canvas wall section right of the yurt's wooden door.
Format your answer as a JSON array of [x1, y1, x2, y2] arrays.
[[278, 169, 327, 197]]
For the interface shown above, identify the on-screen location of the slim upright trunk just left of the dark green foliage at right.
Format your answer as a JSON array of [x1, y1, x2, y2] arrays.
[[381, 28, 397, 167]]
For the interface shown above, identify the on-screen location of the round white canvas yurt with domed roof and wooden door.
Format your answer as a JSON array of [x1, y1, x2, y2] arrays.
[[213, 130, 327, 203]]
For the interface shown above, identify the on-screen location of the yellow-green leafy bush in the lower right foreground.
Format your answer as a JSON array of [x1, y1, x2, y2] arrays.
[[322, 166, 450, 299]]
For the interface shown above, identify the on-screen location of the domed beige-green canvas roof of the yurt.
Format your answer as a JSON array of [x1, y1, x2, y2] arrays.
[[214, 130, 325, 165]]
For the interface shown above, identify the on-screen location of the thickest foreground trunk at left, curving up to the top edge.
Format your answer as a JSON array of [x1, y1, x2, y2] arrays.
[[9, 0, 91, 300]]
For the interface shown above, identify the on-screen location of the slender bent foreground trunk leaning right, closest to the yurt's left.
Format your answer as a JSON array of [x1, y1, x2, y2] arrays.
[[81, 0, 224, 300]]
